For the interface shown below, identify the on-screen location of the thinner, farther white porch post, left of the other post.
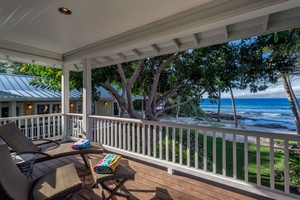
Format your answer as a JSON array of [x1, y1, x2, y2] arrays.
[[61, 65, 70, 140]]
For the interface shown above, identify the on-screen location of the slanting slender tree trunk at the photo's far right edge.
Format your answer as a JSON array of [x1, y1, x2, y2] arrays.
[[281, 74, 300, 135]]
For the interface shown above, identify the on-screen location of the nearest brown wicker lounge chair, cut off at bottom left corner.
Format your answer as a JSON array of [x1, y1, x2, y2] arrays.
[[0, 144, 83, 200]]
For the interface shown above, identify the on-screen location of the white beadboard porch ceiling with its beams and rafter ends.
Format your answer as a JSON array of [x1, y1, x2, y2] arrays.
[[0, 0, 300, 71]]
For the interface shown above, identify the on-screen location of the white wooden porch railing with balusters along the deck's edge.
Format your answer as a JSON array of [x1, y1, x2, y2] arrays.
[[0, 114, 300, 199]]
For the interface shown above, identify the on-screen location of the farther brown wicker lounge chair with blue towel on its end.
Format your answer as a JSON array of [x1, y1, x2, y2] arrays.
[[0, 122, 103, 167]]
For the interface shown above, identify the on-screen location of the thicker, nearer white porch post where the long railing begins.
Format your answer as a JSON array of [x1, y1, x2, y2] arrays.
[[82, 58, 92, 140]]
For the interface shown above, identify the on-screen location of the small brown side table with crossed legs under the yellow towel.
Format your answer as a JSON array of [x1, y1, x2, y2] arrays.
[[90, 159, 135, 200]]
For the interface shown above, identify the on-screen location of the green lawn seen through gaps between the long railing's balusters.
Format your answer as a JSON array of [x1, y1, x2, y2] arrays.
[[158, 129, 290, 190]]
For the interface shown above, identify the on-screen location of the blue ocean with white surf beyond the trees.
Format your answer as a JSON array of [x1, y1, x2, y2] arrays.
[[200, 98, 296, 131]]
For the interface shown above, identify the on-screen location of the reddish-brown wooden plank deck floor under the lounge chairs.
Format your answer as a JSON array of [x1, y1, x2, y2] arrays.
[[34, 154, 272, 200]]
